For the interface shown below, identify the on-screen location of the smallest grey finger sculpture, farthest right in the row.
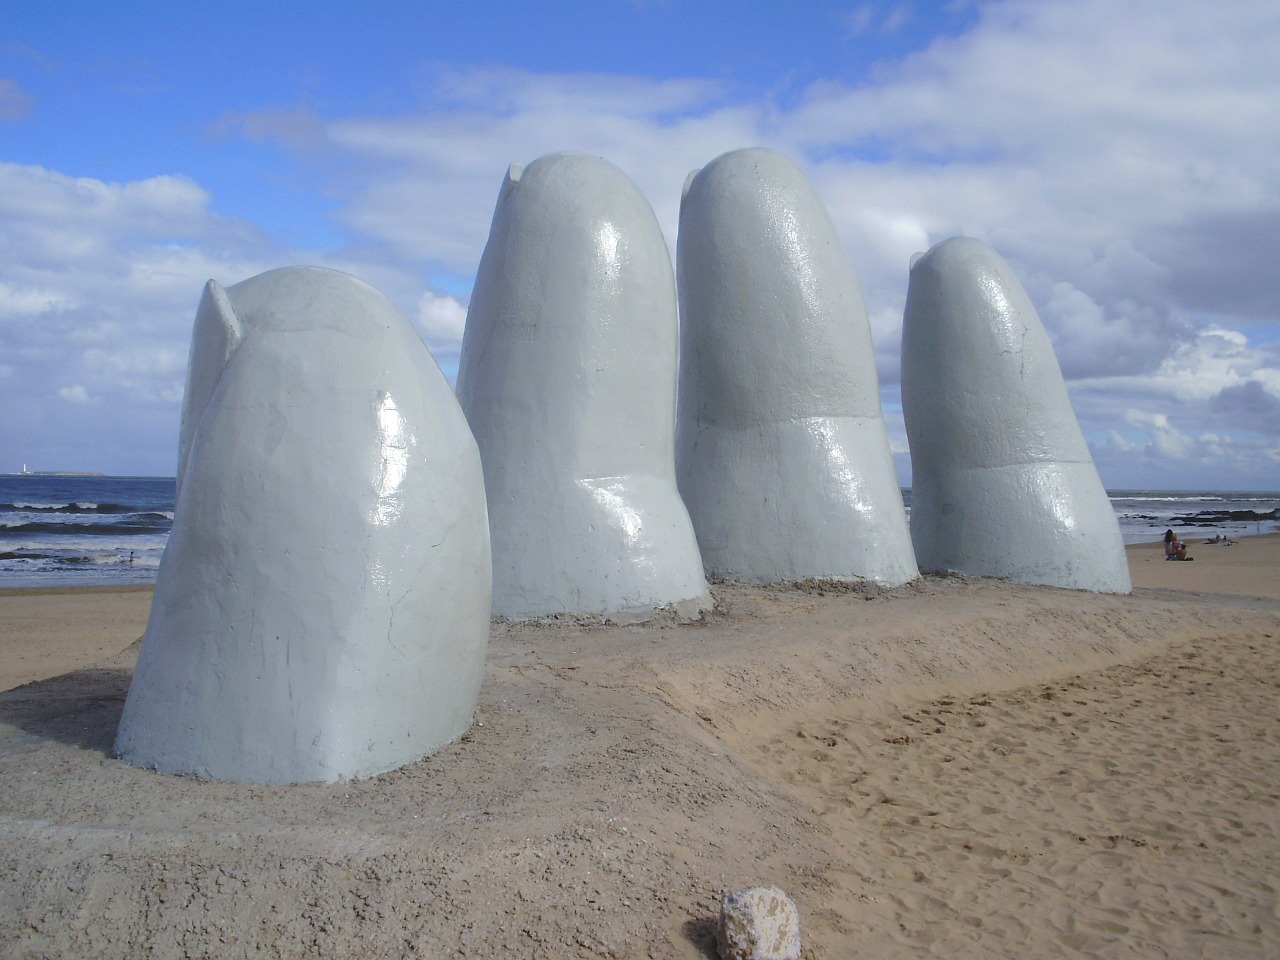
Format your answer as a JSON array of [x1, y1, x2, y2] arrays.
[[902, 237, 1132, 593]]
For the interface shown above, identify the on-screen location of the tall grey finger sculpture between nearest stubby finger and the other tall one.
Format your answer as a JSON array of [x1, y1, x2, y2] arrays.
[[458, 154, 710, 620]]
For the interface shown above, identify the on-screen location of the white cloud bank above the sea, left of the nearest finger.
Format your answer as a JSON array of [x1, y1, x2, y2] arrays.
[[0, 164, 282, 472]]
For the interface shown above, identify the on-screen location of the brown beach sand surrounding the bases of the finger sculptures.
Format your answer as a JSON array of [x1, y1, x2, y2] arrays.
[[0, 536, 1280, 957]]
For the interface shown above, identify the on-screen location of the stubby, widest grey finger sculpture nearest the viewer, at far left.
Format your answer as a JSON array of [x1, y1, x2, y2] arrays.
[[115, 268, 490, 783]]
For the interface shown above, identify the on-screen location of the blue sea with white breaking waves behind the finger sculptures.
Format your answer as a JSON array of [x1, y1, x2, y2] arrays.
[[0, 474, 1280, 588]]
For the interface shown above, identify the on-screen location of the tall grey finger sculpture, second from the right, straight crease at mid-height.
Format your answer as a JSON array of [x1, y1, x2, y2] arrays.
[[676, 150, 918, 586]]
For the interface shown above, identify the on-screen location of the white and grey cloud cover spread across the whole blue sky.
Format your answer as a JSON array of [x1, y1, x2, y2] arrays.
[[0, 0, 1280, 486]]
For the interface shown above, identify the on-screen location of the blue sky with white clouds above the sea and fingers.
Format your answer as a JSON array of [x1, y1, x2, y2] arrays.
[[0, 0, 1280, 489]]
